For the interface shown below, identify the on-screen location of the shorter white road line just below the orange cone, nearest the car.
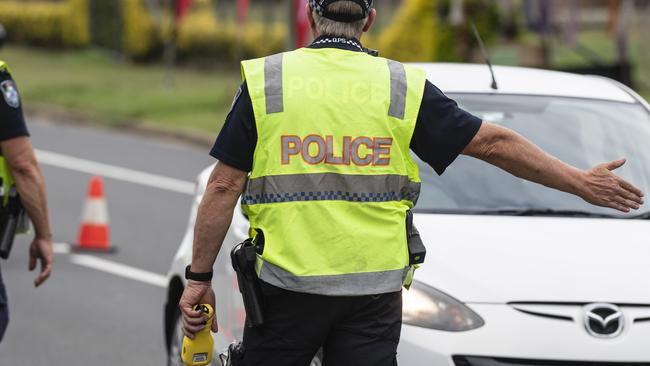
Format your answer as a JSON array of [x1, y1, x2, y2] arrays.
[[70, 254, 167, 288]]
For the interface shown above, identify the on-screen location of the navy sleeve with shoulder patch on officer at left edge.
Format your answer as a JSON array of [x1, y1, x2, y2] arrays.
[[0, 70, 29, 141]]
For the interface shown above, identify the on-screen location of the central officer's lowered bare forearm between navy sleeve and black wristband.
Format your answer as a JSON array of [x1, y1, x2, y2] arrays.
[[191, 163, 247, 273]]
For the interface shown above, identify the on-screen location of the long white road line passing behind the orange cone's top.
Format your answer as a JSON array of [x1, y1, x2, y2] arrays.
[[36, 150, 194, 195]]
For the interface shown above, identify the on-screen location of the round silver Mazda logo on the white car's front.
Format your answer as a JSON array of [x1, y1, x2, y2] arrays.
[[584, 303, 625, 338]]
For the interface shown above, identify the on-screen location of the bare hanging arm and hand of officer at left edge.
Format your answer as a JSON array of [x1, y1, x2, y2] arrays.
[[0, 137, 54, 286]]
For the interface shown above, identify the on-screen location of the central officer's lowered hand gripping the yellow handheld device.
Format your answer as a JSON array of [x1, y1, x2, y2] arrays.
[[178, 280, 219, 339]]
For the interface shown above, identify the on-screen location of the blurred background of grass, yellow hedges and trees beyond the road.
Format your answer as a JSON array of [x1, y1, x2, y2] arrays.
[[0, 0, 650, 139]]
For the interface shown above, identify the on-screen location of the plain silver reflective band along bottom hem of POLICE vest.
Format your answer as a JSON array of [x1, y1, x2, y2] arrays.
[[259, 262, 409, 296]]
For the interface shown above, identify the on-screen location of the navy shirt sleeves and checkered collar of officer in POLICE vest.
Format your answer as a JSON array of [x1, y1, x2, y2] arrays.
[[210, 37, 482, 174]]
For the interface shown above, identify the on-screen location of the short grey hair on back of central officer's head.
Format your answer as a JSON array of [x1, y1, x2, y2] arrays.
[[312, 1, 368, 38]]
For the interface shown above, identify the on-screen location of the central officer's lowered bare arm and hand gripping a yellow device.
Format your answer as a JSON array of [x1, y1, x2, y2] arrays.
[[179, 162, 248, 338]]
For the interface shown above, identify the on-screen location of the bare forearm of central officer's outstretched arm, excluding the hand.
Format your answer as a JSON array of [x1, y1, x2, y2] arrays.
[[463, 122, 586, 195]]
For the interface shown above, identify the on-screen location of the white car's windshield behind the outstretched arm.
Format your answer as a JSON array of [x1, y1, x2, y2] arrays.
[[416, 94, 650, 218]]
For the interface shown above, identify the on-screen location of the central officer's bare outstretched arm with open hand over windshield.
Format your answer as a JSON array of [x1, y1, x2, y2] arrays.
[[463, 122, 643, 212]]
